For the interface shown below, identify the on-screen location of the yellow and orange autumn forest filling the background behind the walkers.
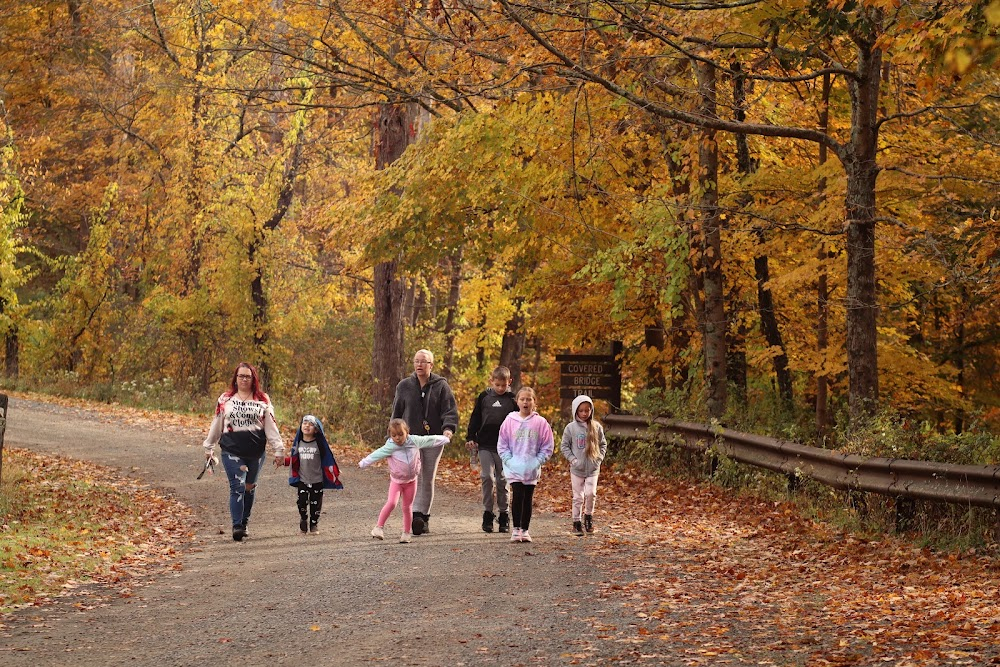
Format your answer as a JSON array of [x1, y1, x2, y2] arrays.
[[0, 0, 1000, 470]]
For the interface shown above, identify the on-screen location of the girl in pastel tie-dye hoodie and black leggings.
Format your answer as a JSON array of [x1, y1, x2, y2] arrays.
[[497, 387, 555, 542]]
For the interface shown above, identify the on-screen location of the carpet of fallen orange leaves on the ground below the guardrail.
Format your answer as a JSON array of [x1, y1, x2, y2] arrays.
[[442, 457, 1000, 667]]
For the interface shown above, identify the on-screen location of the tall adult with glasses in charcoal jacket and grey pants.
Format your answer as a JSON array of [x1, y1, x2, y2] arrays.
[[392, 350, 458, 535]]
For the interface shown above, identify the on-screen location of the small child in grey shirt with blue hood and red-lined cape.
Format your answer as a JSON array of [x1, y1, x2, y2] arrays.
[[288, 415, 344, 535]]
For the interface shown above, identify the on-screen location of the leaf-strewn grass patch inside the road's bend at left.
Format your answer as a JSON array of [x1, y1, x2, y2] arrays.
[[0, 448, 189, 618]]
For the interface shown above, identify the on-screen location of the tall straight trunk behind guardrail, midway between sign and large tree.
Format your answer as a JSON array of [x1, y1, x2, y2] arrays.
[[694, 62, 727, 419]]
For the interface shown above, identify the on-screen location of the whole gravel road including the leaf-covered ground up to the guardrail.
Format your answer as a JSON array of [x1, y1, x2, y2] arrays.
[[7, 400, 1000, 667]]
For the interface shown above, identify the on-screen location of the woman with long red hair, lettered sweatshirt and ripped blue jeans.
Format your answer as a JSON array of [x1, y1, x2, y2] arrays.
[[204, 362, 285, 542]]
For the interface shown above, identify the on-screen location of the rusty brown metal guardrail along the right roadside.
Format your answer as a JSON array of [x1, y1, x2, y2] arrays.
[[603, 415, 1000, 508]]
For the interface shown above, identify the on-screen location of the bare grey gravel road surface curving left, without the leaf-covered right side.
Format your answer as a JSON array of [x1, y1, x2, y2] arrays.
[[0, 400, 652, 667]]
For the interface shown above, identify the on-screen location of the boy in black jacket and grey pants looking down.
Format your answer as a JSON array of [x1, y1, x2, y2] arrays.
[[465, 366, 517, 533]]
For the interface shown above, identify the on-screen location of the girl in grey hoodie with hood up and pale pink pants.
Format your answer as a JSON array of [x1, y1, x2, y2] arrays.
[[560, 396, 608, 535]]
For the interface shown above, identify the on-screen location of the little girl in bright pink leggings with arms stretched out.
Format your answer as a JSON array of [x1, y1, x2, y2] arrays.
[[358, 419, 449, 543]]
